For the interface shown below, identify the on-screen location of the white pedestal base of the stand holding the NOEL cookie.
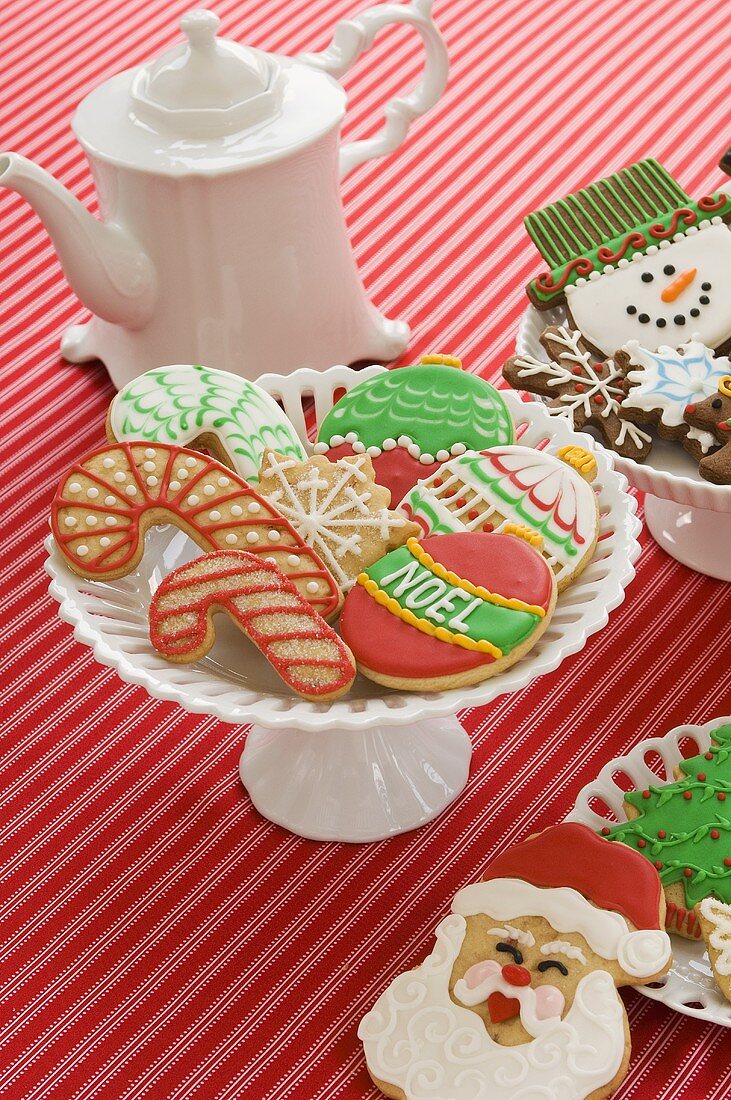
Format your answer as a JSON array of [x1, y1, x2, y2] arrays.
[[239, 717, 472, 843]]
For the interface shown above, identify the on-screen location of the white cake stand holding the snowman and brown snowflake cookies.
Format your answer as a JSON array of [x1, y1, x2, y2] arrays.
[[516, 306, 731, 581]]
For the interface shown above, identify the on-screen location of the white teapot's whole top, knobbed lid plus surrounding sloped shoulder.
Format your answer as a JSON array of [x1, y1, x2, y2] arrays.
[[73, 9, 346, 177]]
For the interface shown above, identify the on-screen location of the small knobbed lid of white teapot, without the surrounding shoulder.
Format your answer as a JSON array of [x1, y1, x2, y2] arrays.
[[131, 9, 284, 138]]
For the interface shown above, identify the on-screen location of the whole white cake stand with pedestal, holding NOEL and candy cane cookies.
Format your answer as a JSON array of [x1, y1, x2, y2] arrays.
[[46, 366, 640, 842]]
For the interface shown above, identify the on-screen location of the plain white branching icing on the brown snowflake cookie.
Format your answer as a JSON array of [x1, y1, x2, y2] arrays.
[[514, 326, 652, 450]]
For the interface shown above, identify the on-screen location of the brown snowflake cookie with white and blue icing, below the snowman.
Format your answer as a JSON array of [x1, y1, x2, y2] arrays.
[[614, 340, 731, 461]]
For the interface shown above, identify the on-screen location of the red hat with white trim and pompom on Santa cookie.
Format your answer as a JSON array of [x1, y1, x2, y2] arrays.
[[452, 822, 671, 978]]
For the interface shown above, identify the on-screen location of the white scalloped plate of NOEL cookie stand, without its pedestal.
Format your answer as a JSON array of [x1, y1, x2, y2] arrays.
[[46, 366, 640, 730]]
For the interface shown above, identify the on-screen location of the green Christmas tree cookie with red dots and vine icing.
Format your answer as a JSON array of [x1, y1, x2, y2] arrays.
[[601, 725, 731, 939]]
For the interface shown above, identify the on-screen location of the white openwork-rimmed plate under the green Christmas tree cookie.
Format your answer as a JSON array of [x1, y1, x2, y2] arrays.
[[566, 716, 731, 1027]]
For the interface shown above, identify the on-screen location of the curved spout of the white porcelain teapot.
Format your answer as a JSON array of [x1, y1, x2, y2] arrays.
[[0, 153, 157, 329]]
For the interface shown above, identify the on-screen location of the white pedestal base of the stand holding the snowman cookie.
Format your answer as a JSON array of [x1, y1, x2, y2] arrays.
[[644, 493, 731, 581]]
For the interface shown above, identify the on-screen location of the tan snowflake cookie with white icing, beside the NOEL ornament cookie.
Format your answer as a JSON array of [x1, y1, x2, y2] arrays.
[[261, 451, 408, 590]]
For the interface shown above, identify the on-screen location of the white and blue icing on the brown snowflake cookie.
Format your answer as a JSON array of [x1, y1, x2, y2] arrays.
[[622, 336, 731, 429]]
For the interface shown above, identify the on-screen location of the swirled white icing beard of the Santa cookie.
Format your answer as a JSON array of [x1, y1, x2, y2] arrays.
[[358, 915, 624, 1100]]
